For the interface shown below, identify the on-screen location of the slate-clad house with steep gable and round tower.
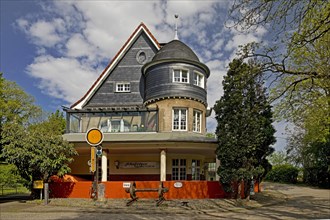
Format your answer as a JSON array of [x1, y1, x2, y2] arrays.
[[60, 23, 223, 199]]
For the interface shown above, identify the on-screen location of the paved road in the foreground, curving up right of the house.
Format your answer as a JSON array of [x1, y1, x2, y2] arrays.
[[0, 183, 330, 220]]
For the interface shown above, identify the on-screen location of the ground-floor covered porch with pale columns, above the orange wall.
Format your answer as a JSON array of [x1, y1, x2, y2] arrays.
[[65, 132, 217, 182]]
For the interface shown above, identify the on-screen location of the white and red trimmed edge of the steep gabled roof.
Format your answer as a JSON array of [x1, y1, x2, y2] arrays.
[[70, 23, 161, 109]]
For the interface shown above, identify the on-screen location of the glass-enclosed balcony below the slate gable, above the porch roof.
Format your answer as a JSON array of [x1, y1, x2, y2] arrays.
[[66, 110, 158, 133]]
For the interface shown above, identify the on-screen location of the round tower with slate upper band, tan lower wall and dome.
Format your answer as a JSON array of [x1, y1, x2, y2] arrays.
[[142, 40, 210, 134]]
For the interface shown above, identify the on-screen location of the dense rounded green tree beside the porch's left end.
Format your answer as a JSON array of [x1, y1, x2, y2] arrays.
[[2, 112, 77, 186]]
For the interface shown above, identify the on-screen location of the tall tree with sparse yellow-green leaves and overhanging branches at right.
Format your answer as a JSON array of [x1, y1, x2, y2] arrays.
[[231, 0, 330, 188]]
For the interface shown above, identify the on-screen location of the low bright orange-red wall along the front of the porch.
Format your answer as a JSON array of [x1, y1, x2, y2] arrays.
[[50, 181, 229, 199]]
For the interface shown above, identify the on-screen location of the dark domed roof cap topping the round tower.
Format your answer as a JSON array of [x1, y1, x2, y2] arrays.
[[152, 40, 199, 62]]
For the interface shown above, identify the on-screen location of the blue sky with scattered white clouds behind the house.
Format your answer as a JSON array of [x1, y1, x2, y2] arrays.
[[0, 0, 285, 149]]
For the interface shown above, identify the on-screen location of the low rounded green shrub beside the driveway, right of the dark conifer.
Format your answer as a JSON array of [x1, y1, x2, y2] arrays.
[[265, 164, 299, 183]]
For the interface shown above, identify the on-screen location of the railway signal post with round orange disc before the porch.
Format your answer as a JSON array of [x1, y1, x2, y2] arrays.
[[86, 128, 104, 200]]
